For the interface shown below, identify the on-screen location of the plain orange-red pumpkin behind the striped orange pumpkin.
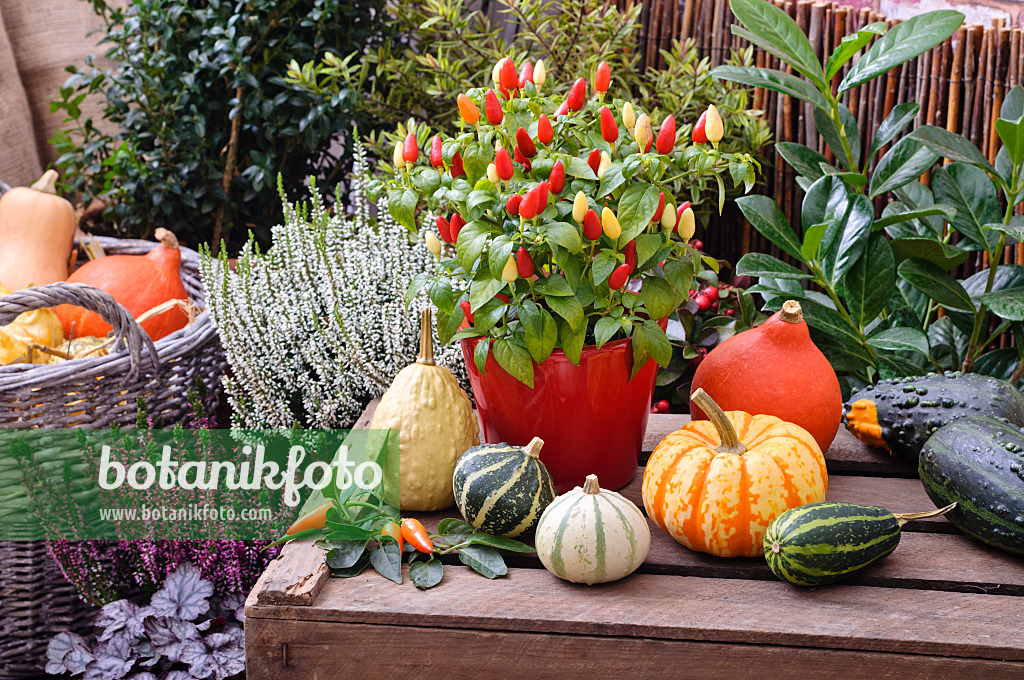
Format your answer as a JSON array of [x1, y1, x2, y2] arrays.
[[690, 300, 843, 451]]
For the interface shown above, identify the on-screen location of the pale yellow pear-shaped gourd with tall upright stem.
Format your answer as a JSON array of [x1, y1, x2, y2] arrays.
[[370, 309, 480, 512]]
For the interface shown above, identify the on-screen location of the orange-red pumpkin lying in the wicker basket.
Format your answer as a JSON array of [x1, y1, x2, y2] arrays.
[[55, 229, 188, 340]]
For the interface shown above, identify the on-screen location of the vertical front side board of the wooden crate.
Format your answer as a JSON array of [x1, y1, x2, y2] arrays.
[[246, 619, 1024, 680]]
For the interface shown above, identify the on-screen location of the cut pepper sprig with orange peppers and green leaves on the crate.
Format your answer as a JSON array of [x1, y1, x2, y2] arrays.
[[278, 494, 535, 589]]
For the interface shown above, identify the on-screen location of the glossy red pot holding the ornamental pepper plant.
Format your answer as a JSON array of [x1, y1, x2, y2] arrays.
[[462, 331, 657, 494]]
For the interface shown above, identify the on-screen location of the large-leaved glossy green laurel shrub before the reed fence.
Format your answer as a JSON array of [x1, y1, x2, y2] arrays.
[[714, 0, 1024, 393]]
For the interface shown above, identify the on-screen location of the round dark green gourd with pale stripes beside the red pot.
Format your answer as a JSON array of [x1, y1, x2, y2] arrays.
[[453, 437, 557, 538]]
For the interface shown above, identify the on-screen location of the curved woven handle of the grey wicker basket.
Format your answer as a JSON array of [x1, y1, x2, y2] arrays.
[[0, 283, 160, 382]]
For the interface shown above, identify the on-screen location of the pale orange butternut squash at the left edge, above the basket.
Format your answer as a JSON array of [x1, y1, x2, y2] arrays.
[[0, 170, 77, 291]]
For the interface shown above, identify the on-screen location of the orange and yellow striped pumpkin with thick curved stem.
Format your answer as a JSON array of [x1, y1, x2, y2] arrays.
[[643, 389, 828, 557]]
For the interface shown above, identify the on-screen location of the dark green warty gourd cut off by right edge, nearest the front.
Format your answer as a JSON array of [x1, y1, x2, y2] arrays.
[[918, 418, 1024, 555]]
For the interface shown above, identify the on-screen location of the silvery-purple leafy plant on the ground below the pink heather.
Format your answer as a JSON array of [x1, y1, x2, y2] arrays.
[[46, 563, 245, 680]]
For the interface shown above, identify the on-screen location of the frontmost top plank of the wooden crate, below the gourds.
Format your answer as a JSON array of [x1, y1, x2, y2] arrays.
[[246, 566, 1024, 662]]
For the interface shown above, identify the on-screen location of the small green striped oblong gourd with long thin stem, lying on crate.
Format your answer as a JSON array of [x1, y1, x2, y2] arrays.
[[764, 502, 955, 586]]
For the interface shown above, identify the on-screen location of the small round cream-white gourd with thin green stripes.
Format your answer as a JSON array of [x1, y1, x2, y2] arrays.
[[537, 474, 650, 584]]
